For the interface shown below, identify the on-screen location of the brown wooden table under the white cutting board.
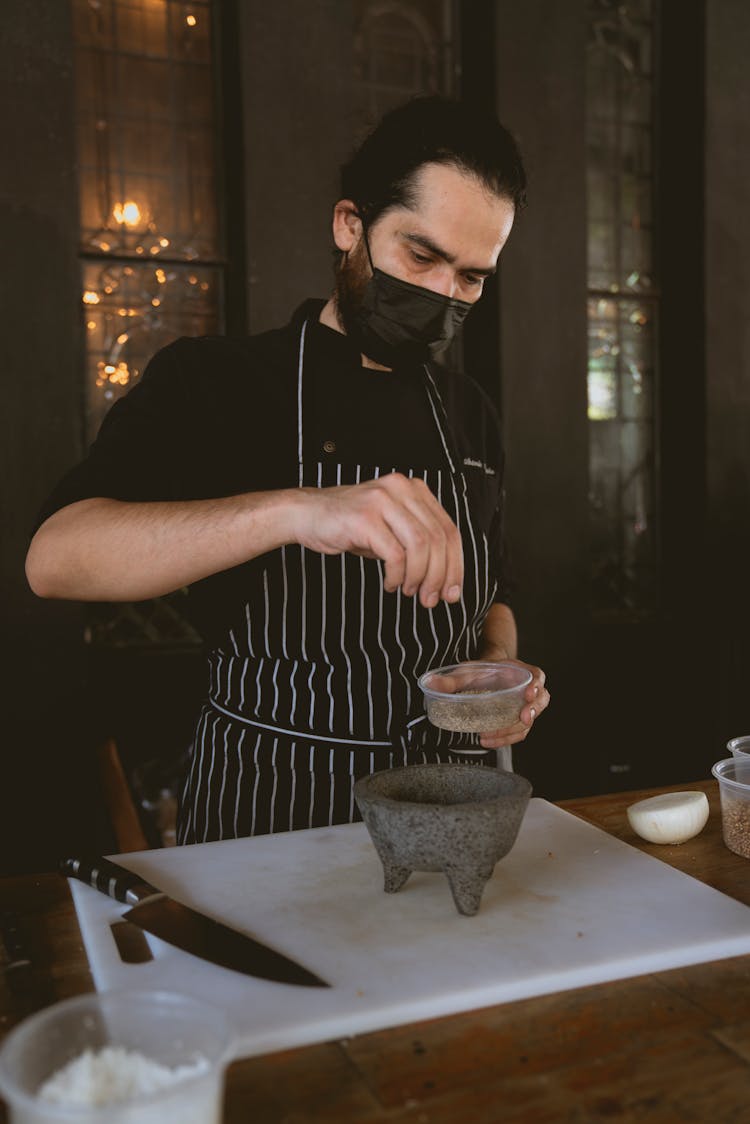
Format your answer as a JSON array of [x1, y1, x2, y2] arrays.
[[0, 781, 750, 1124]]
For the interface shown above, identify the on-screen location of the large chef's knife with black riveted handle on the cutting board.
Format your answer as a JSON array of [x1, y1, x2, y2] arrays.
[[60, 859, 331, 987]]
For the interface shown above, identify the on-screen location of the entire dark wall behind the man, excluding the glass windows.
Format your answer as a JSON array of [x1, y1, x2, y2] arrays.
[[0, 0, 750, 869]]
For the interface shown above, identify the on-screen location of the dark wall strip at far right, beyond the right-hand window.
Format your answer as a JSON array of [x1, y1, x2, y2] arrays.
[[706, 0, 750, 745]]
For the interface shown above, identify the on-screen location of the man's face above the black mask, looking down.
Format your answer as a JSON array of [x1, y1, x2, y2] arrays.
[[336, 164, 515, 330]]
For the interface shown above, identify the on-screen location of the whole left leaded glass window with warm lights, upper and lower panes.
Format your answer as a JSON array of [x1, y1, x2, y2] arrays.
[[72, 0, 224, 646]]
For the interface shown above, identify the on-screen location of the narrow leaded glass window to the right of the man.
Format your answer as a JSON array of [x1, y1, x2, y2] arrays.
[[587, 0, 659, 615]]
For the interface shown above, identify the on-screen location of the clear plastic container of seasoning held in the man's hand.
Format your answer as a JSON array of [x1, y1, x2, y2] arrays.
[[419, 660, 532, 734]]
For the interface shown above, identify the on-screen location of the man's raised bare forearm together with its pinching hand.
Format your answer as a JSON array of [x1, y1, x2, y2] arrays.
[[26, 472, 474, 608]]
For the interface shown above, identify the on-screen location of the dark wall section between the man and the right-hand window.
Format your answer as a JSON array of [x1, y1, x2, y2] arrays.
[[496, 0, 588, 795]]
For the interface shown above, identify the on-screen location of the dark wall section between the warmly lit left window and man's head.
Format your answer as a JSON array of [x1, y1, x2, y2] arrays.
[[238, 0, 360, 332]]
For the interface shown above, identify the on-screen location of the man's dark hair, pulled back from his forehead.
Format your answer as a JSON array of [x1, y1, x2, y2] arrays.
[[341, 97, 526, 225]]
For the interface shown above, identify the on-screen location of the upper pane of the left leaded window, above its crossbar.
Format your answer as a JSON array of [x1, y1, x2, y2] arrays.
[[74, 0, 220, 261]]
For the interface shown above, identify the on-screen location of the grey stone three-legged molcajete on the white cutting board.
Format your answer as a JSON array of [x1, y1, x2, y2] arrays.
[[354, 764, 531, 916]]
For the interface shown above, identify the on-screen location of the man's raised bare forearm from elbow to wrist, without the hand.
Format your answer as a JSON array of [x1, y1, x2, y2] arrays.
[[26, 490, 297, 601]]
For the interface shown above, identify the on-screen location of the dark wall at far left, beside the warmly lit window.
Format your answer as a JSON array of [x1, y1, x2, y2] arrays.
[[0, 0, 108, 869]]
